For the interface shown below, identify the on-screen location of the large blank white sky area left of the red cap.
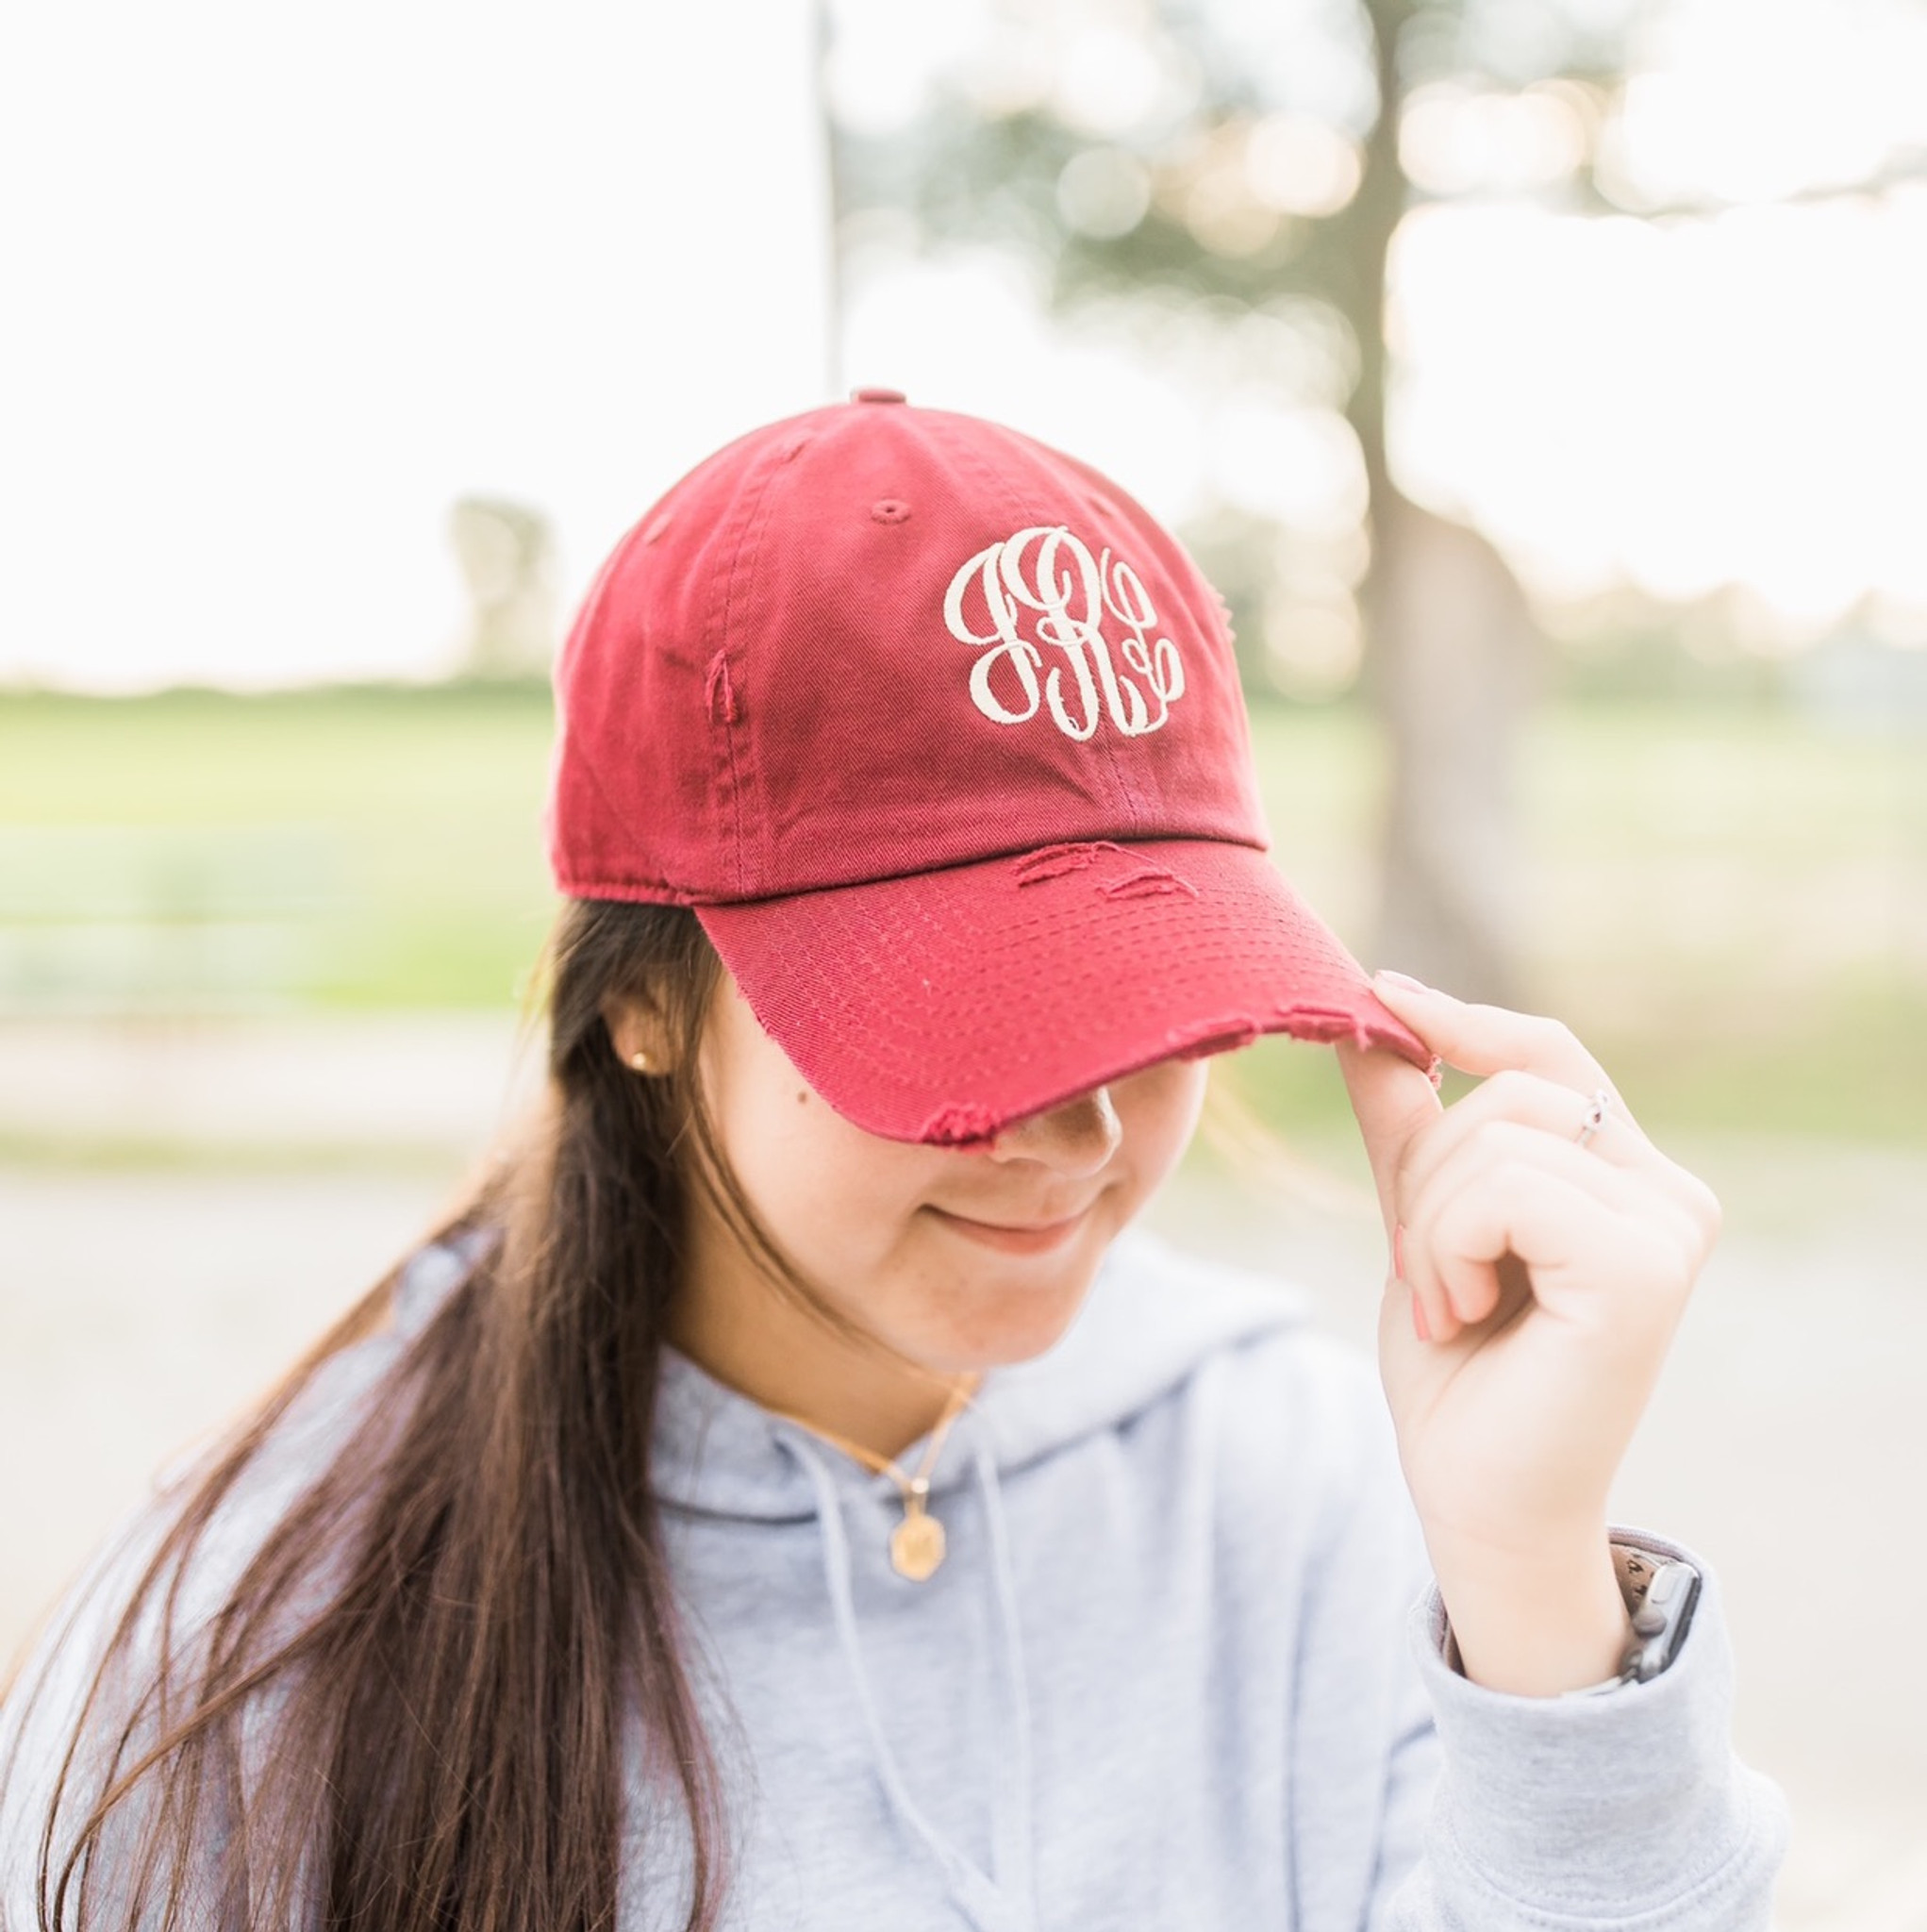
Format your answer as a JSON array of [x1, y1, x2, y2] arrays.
[[0, 0, 828, 686]]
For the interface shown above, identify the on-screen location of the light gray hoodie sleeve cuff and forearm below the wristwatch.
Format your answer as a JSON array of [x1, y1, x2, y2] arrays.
[[1369, 1532, 1786, 1932]]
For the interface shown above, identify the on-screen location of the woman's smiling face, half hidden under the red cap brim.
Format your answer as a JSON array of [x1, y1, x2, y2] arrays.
[[691, 974, 1204, 1374]]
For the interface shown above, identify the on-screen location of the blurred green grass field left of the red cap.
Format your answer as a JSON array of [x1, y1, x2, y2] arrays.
[[0, 684, 552, 1010]]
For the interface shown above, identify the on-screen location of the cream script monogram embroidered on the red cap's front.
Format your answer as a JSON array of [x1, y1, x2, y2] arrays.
[[944, 525, 1184, 738]]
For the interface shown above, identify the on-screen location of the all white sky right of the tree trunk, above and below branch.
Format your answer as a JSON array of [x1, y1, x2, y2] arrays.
[[1394, 0, 1927, 643]]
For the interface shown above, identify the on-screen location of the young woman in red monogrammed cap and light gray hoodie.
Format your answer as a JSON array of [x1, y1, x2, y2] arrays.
[[0, 391, 1782, 1932]]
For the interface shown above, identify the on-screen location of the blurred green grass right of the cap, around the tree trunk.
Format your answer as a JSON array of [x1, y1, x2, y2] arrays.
[[1241, 703, 1927, 1143]]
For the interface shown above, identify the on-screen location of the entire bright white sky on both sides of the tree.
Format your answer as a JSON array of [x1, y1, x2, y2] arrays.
[[0, 0, 1927, 688]]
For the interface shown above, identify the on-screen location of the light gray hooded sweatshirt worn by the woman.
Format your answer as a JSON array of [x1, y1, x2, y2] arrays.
[[0, 1237, 1786, 1932]]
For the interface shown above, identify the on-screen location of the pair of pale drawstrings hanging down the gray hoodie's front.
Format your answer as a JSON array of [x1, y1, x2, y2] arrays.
[[776, 1432, 1035, 1932]]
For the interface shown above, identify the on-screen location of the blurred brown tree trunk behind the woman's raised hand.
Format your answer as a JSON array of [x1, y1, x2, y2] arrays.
[[1348, 0, 1539, 1005]]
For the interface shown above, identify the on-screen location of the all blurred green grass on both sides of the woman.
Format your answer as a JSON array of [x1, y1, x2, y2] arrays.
[[0, 684, 1927, 1141]]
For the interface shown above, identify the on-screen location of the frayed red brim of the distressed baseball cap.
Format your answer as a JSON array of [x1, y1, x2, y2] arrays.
[[697, 839, 1433, 1145]]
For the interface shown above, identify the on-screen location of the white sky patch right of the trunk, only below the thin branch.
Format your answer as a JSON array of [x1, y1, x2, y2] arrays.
[[1396, 192, 1927, 625]]
